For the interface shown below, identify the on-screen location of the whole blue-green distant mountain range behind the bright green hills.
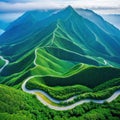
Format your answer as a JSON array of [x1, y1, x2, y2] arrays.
[[0, 6, 120, 62]]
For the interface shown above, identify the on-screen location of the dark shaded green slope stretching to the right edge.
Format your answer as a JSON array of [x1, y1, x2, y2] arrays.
[[26, 66, 120, 88]]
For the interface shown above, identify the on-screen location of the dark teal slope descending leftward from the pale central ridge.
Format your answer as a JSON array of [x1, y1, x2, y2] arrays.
[[1, 21, 56, 62]]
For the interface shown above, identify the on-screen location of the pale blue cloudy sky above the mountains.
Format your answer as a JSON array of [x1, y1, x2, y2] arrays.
[[0, 0, 120, 29]]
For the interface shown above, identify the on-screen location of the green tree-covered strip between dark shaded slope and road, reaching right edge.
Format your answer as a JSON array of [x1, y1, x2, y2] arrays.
[[27, 79, 120, 101]]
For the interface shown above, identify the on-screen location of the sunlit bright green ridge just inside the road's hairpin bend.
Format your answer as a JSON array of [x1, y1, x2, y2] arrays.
[[26, 80, 92, 100]]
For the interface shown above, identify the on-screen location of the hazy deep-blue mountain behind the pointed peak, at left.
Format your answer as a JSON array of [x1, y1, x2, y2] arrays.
[[0, 10, 57, 45]]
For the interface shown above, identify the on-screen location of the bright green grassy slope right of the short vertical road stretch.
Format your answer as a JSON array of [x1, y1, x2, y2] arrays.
[[36, 49, 74, 73]]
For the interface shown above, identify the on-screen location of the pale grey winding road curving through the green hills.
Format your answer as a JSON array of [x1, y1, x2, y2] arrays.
[[0, 49, 120, 111]]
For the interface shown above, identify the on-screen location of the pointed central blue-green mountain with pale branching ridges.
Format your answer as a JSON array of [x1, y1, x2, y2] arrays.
[[2, 6, 120, 67]]
